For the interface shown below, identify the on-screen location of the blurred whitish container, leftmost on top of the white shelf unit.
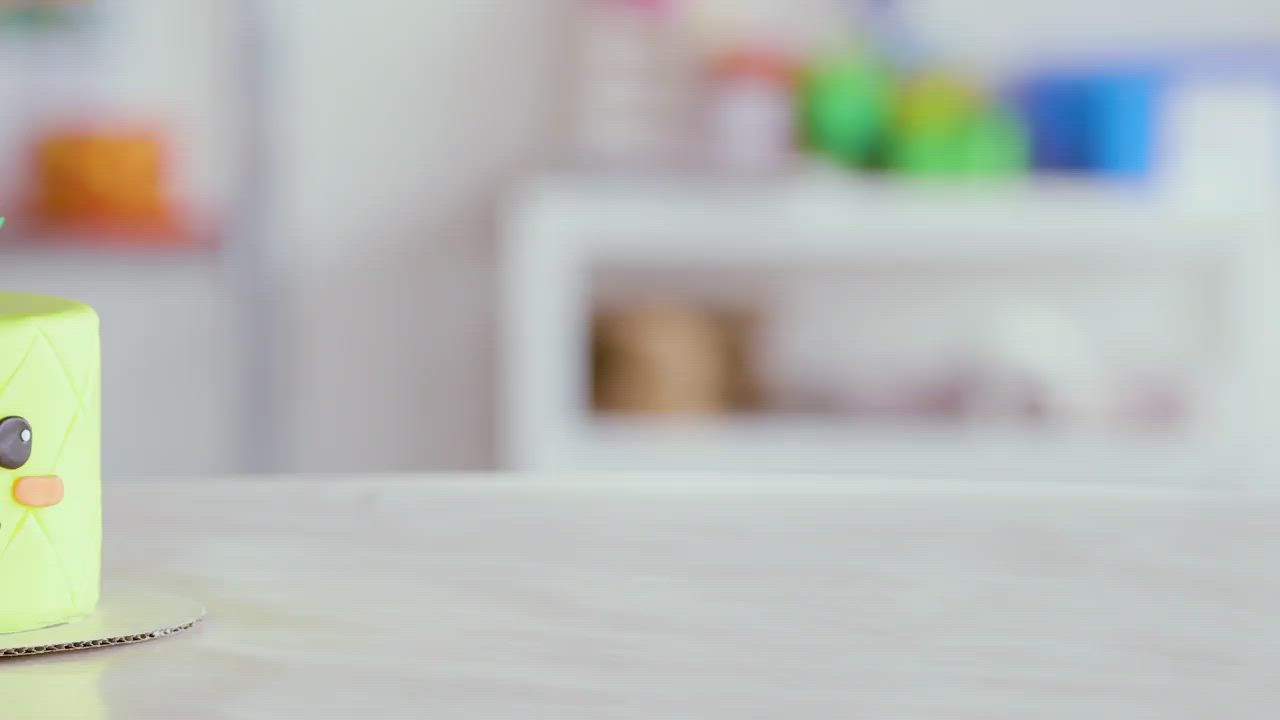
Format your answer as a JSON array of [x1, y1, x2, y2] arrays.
[[572, 0, 696, 169]]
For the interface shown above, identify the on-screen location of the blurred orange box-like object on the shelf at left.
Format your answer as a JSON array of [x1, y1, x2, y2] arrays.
[[32, 122, 189, 245]]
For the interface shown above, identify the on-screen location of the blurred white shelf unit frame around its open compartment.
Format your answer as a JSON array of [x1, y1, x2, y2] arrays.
[[499, 170, 1280, 480]]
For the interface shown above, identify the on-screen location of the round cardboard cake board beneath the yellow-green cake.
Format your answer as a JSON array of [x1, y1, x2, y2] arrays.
[[0, 591, 205, 659]]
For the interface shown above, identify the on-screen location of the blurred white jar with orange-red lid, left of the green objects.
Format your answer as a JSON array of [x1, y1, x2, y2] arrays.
[[708, 49, 796, 176]]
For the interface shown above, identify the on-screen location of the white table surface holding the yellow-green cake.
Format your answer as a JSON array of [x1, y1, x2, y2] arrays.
[[0, 477, 1280, 720]]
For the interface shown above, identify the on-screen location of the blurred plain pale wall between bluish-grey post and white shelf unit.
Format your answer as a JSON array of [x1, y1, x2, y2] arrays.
[[276, 0, 567, 471]]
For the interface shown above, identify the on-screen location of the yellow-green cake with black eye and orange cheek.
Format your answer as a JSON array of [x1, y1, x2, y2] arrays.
[[0, 292, 102, 633]]
